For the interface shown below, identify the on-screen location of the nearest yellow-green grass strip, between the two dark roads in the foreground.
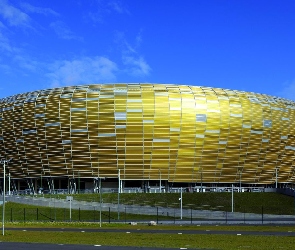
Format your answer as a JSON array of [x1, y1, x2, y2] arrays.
[[0, 227, 295, 250]]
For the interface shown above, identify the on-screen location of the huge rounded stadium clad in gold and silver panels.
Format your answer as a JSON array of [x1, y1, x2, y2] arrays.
[[0, 83, 295, 191]]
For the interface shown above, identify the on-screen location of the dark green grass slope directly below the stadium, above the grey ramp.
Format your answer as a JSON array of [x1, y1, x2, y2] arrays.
[[41, 192, 295, 215]]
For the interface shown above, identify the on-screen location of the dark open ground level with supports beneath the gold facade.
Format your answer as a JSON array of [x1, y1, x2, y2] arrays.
[[0, 178, 293, 195]]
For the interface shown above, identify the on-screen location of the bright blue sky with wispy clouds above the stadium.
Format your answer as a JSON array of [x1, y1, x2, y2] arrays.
[[0, 0, 295, 100]]
